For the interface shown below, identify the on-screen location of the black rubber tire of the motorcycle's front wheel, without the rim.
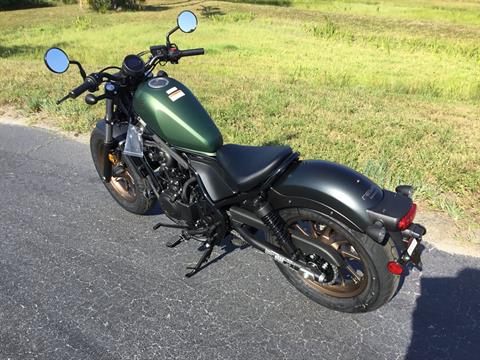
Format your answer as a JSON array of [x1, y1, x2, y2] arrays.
[[90, 129, 155, 215]]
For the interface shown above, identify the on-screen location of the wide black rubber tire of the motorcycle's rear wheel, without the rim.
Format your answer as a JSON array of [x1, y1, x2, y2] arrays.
[[267, 209, 401, 313]]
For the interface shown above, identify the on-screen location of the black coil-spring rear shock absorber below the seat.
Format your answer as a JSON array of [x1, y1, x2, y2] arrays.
[[255, 202, 298, 260]]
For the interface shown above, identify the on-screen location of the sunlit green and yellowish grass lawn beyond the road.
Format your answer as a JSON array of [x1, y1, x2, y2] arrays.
[[0, 0, 480, 242]]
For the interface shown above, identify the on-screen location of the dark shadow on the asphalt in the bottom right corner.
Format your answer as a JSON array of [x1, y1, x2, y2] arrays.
[[406, 269, 480, 360]]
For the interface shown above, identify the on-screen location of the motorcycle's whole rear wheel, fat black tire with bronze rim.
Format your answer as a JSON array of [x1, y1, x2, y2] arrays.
[[267, 209, 400, 313]]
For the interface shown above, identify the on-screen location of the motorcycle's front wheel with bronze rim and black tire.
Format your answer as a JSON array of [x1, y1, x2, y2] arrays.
[[90, 129, 155, 215]]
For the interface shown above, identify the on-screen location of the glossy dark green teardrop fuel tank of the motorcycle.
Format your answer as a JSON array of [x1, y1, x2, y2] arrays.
[[133, 77, 223, 156]]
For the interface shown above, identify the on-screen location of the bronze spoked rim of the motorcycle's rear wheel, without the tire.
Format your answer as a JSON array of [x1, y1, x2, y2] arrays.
[[289, 220, 368, 298]]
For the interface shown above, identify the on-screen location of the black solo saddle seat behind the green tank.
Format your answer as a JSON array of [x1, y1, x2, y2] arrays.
[[217, 144, 292, 191]]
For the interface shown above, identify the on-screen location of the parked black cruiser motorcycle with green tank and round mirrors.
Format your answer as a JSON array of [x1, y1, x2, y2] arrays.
[[44, 11, 426, 312]]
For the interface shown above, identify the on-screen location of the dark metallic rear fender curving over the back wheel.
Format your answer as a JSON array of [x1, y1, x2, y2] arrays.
[[268, 160, 384, 232]]
